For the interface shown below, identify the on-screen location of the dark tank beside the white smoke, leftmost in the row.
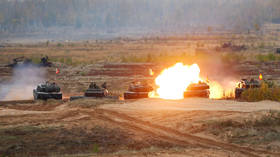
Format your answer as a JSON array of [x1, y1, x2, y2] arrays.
[[33, 82, 62, 100]]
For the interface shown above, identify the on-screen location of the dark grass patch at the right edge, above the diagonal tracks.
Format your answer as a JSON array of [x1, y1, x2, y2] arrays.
[[207, 111, 280, 149]]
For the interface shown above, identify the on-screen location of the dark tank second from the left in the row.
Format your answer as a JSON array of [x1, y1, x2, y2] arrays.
[[85, 82, 109, 98]]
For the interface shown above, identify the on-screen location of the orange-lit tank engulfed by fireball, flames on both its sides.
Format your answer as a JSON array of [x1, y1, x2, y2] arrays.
[[184, 81, 210, 98]]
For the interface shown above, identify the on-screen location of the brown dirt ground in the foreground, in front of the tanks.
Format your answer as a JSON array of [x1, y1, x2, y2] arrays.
[[0, 98, 280, 156]]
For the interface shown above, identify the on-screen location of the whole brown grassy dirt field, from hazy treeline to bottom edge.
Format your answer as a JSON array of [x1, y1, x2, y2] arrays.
[[0, 35, 280, 157]]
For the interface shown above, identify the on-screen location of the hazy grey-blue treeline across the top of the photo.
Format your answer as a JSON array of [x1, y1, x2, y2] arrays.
[[0, 0, 280, 32]]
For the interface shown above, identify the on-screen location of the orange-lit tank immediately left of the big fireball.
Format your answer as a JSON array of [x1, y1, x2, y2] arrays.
[[124, 82, 153, 99]]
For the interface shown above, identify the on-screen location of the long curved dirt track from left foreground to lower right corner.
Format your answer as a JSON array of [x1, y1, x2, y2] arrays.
[[2, 103, 280, 156]]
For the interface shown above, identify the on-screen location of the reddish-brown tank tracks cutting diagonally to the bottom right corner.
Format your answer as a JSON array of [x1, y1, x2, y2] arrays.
[[87, 109, 280, 157]]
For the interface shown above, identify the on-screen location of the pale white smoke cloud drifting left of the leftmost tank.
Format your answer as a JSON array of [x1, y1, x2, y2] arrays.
[[0, 65, 45, 101]]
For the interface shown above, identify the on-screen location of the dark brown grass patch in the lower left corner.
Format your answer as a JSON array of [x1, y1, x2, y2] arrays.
[[0, 126, 133, 157]]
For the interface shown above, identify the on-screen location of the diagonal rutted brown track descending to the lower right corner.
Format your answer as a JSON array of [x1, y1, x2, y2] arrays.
[[96, 109, 280, 157]]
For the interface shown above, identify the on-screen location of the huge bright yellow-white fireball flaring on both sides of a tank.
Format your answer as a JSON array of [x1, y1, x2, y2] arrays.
[[149, 63, 234, 100]]
